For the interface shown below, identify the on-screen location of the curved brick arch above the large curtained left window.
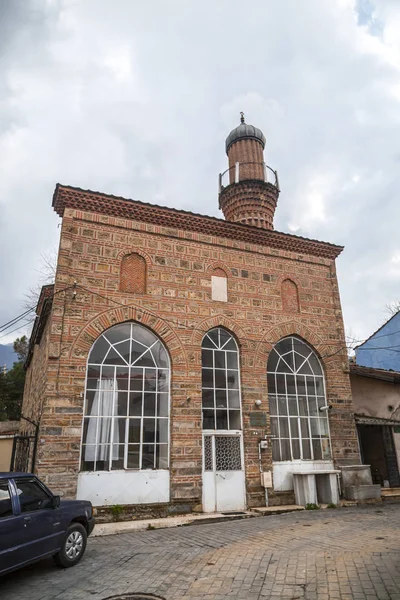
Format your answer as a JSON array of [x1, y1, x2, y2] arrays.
[[69, 305, 187, 367]]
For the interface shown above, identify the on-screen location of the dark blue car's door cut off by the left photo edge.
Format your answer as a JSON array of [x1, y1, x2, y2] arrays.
[[0, 479, 23, 573]]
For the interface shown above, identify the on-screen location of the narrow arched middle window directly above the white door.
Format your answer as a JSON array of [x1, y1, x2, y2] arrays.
[[201, 327, 242, 430]]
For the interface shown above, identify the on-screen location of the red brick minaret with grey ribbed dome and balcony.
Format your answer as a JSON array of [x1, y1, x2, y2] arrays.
[[219, 113, 279, 229]]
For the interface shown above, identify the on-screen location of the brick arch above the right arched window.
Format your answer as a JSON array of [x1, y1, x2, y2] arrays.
[[254, 321, 332, 372]]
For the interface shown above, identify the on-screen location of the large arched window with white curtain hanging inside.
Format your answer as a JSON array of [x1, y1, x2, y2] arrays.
[[81, 323, 170, 471]]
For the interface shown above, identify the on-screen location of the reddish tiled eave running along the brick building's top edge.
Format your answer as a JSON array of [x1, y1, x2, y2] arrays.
[[52, 183, 343, 259]]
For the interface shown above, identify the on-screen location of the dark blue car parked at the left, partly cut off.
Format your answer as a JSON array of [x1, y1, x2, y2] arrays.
[[0, 473, 95, 575]]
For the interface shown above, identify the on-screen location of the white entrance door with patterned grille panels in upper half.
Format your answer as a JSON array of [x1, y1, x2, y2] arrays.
[[203, 433, 246, 512]]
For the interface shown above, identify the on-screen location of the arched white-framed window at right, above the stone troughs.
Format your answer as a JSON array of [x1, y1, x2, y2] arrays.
[[267, 337, 331, 461]]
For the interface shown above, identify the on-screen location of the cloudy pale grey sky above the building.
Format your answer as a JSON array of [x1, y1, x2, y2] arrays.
[[0, 0, 400, 343]]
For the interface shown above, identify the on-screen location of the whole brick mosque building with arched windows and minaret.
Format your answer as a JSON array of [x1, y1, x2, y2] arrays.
[[23, 120, 360, 514]]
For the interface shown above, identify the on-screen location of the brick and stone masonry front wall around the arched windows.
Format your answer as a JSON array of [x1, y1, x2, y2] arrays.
[[28, 208, 359, 506]]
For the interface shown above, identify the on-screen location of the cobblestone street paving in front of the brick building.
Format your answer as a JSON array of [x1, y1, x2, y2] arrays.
[[0, 504, 400, 600]]
